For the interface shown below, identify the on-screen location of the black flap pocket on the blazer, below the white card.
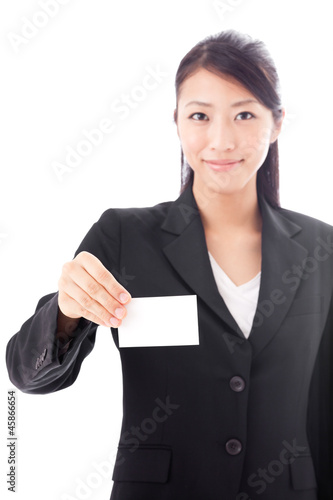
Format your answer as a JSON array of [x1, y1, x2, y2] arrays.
[[112, 446, 171, 483]]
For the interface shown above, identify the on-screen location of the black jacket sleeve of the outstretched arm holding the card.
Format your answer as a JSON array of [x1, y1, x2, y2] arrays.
[[6, 209, 120, 394]]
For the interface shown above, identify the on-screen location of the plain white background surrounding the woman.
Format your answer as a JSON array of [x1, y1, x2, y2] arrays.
[[0, 0, 333, 500]]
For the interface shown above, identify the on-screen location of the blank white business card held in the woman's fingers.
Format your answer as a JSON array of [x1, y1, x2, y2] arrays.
[[118, 295, 199, 347]]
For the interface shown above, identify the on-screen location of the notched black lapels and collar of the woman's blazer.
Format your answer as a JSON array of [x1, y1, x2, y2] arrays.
[[162, 186, 308, 355]]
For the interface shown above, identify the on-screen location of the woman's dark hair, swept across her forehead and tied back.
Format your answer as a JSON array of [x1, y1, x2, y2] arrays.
[[175, 30, 282, 208]]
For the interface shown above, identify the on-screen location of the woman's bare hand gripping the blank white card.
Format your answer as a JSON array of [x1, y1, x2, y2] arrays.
[[58, 252, 131, 328]]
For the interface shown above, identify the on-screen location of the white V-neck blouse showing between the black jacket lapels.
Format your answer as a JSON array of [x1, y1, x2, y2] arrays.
[[208, 252, 261, 338]]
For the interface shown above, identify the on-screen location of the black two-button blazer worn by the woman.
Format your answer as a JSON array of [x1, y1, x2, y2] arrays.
[[7, 187, 333, 500]]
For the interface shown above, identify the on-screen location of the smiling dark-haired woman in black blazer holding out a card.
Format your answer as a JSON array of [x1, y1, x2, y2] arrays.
[[7, 31, 333, 500]]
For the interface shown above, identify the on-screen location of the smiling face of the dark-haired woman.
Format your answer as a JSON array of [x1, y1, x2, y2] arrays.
[[177, 68, 282, 203]]
